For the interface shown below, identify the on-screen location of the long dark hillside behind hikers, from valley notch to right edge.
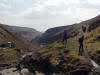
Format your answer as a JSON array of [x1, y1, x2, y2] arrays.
[[32, 16, 100, 44]]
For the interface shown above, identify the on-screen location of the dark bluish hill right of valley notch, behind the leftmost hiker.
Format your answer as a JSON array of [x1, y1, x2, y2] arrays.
[[32, 24, 79, 44]]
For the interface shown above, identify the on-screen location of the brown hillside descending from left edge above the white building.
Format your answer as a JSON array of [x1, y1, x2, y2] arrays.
[[0, 24, 35, 49]]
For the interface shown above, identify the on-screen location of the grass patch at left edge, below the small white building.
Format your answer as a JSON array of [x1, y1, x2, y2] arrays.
[[0, 48, 18, 64]]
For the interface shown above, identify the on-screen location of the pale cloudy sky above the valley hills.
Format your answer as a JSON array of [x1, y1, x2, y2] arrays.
[[0, 0, 100, 32]]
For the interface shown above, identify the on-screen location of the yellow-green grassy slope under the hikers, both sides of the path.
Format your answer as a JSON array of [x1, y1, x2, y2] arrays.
[[33, 24, 100, 75]]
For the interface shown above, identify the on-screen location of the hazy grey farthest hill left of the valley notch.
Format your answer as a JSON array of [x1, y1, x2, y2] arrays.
[[5, 25, 41, 41]]
